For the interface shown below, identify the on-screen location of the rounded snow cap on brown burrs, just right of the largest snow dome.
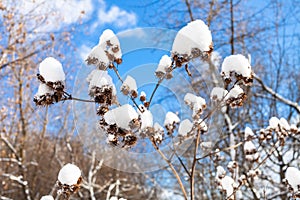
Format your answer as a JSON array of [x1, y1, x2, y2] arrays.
[[221, 54, 251, 78]]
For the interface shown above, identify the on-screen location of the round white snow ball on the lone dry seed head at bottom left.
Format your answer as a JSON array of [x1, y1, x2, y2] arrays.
[[58, 163, 81, 186]]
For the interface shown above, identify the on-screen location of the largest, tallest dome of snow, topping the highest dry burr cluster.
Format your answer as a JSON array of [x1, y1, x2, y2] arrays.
[[172, 19, 212, 56]]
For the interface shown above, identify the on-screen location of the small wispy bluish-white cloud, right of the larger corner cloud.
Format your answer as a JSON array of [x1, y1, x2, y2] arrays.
[[94, 0, 137, 28]]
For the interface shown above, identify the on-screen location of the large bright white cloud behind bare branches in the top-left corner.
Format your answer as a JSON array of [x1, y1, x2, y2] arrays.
[[4, 0, 93, 32]]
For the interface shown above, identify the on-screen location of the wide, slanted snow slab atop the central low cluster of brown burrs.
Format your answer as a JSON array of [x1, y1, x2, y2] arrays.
[[104, 104, 138, 130]]
